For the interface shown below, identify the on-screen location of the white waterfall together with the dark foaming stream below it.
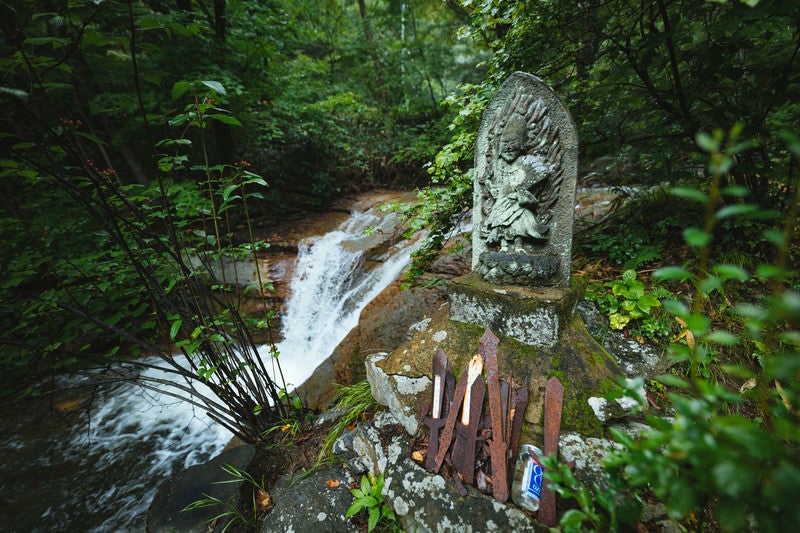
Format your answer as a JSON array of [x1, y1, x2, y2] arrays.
[[0, 202, 414, 533]]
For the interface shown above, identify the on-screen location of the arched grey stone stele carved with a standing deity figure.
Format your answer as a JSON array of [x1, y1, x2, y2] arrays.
[[472, 72, 578, 287]]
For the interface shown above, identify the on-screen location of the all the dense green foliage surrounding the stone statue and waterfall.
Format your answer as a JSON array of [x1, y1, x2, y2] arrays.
[[0, 0, 800, 530]]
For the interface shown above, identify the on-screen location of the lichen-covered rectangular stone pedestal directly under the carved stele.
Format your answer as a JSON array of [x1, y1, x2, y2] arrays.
[[447, 273, 579, 348]]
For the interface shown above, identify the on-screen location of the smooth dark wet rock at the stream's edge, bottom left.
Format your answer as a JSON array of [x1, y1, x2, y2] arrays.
[[146, 445, 256, 533]]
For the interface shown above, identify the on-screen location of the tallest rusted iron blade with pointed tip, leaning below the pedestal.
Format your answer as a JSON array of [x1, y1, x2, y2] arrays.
[[478, 329, 509, 502]]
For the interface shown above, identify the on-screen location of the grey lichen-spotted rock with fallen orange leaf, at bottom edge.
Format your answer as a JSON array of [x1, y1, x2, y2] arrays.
[[261, 466, 359, 533]]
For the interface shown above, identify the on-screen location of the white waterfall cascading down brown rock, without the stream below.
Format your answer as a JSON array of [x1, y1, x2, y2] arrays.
[[268, 209, 417, 389]]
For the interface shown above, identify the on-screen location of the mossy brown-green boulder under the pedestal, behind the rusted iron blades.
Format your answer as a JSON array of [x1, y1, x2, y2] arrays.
[[369, 305, 622, 442]]
